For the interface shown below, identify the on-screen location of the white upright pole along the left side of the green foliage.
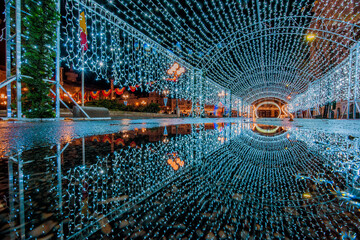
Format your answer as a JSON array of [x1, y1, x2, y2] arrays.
[[15, 0, 22, 119]]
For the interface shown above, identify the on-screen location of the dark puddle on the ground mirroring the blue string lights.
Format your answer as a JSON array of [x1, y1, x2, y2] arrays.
[[0, 122, 360, 239]]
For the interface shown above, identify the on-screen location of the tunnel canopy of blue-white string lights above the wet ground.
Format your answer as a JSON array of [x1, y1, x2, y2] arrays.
[[6, 0, 360, 119]]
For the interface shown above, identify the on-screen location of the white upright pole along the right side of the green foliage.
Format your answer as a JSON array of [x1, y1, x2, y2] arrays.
[[55, 0, 61, 119]]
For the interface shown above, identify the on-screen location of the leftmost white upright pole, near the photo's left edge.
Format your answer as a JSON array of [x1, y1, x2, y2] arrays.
[[5, 0, 11, 118]]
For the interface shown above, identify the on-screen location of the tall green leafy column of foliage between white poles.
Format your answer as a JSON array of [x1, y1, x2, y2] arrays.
[[21, 0, 60, 118]]
